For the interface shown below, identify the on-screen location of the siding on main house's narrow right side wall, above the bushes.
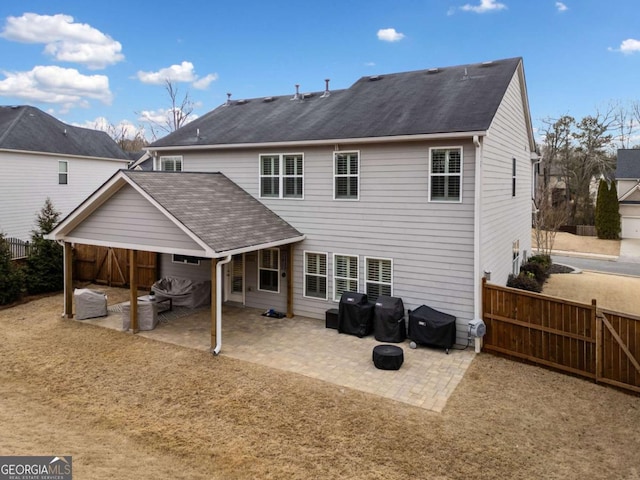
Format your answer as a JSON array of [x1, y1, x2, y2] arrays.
[[481, 67, 532, 285]]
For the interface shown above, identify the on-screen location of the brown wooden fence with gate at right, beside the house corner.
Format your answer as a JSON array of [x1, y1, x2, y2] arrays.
[[482, 281, 640, 393]]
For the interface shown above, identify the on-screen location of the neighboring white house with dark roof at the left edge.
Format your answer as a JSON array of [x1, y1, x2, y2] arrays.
[[0, 105, 129, 240]]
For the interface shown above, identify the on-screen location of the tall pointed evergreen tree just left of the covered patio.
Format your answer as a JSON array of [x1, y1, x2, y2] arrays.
[[26, 198, 64, 294]]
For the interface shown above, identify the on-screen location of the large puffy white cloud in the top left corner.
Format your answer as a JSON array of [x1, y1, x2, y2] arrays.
[[0, 13, 124, 69]]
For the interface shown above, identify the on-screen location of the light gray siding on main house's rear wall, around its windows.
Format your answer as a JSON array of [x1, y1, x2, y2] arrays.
[[179, 139, 475, 330]]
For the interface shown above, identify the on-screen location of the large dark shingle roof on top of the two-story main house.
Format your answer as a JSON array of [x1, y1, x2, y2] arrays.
[[151, 58, 521, 147]]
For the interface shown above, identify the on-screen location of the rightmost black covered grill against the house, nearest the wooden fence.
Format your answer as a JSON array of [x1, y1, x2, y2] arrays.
[[409, 305, 456, 350]]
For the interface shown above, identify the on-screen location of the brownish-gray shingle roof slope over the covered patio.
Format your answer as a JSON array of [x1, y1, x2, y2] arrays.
[[122, 170, 302, 253]]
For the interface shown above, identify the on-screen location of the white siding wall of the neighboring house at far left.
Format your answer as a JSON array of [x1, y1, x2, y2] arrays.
[[0, 152, 127, 240]]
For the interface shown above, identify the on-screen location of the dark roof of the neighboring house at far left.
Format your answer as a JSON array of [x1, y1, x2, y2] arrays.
[[0, 105, 129, 160]]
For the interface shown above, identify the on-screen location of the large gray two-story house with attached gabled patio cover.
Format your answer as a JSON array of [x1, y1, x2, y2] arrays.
[[48, 58, 536, 343]]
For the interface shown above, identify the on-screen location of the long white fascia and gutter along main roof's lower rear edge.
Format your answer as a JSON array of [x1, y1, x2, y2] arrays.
[[147, 130, 487, 152]]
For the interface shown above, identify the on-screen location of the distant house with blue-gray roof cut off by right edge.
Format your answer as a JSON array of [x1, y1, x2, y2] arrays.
[[616, 149, 640, 238]]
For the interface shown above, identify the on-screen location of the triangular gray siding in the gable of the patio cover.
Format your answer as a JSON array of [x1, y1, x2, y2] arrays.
[[69, 185, 202, 251]]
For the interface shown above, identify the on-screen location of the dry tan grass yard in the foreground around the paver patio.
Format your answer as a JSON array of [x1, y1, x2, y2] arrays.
[[0, 290, 640, 480]]
